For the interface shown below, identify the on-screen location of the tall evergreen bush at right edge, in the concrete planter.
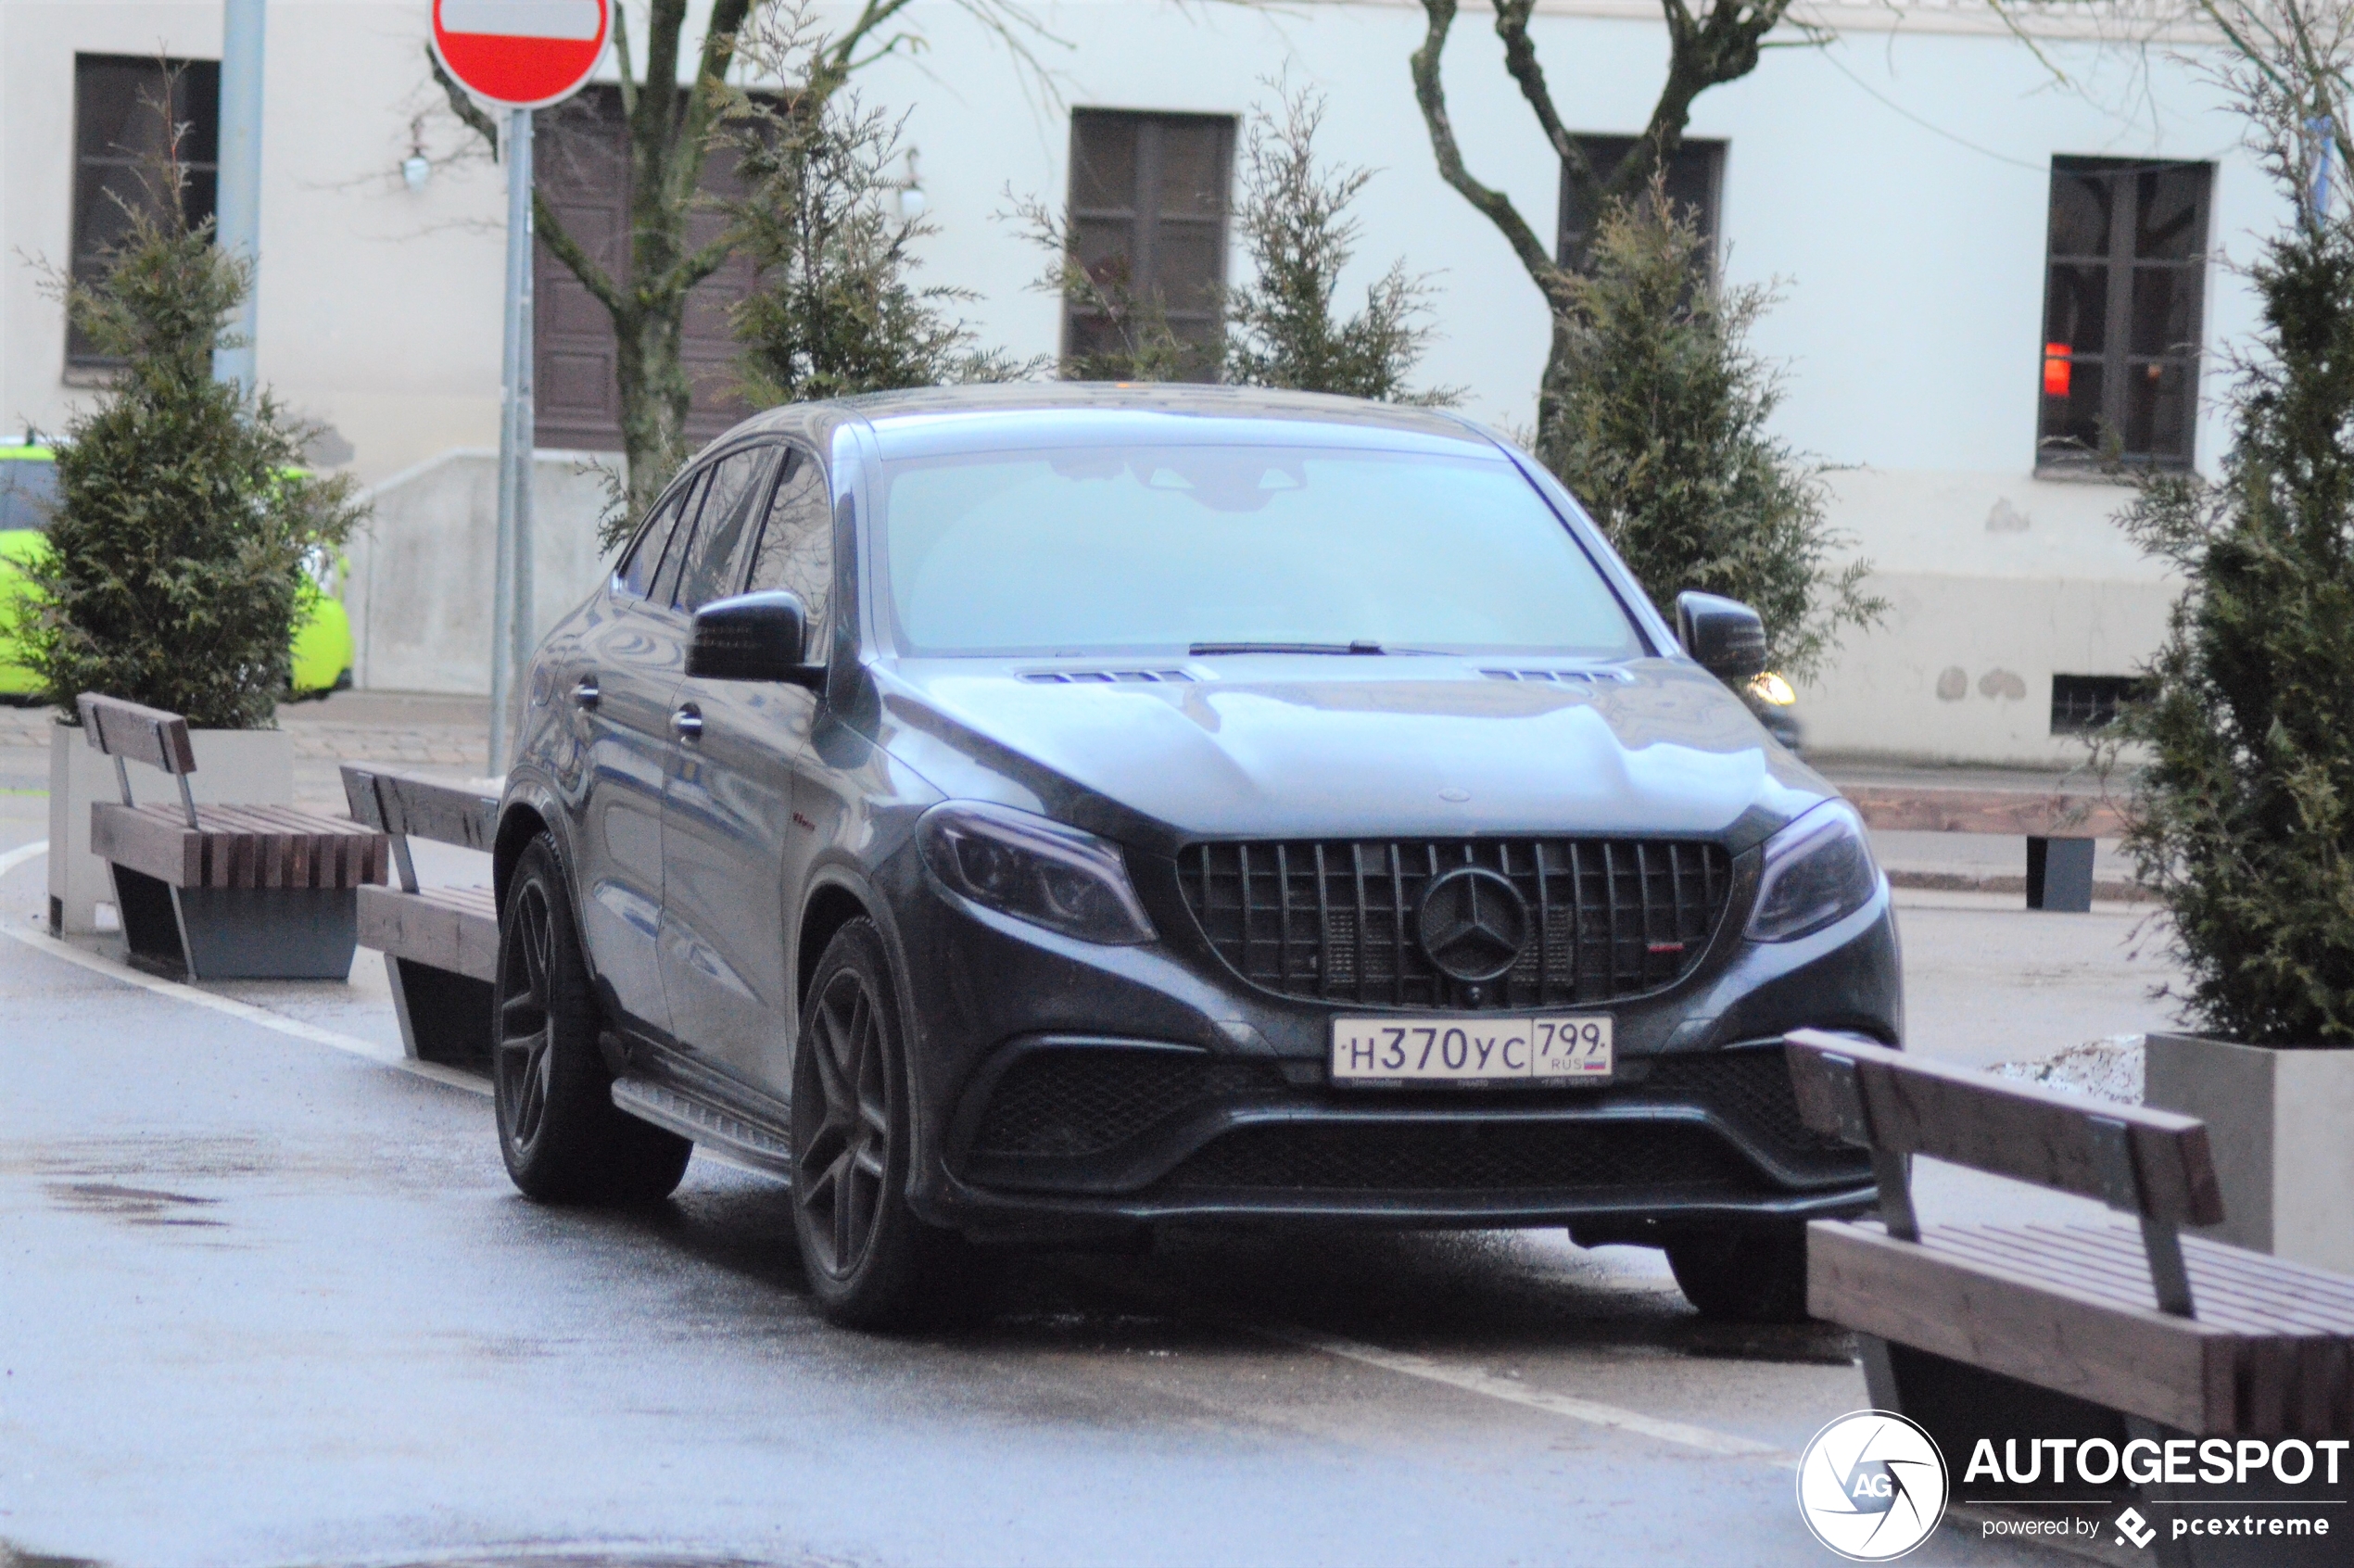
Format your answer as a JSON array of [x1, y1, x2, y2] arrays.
[[2105, 80, 2354, 1045]]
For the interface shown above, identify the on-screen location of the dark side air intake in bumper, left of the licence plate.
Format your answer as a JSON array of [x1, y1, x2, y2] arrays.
[[972, 1048, 1283, 1156]]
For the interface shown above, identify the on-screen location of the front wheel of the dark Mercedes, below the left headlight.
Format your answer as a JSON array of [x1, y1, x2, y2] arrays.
[[791, 920, 975, 1328]]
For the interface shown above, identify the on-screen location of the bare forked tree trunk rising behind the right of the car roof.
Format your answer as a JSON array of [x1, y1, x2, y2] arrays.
[[1412, 0, 1815, 462]]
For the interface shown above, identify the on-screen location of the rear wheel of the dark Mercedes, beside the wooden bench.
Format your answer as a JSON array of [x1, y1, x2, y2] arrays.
[[489, 833, 694, 1206]]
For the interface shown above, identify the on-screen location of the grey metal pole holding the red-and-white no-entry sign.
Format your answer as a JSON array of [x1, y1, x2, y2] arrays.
[[489, 108, 535, 775]]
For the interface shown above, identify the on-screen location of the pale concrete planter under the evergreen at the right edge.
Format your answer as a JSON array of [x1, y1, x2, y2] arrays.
[[2142, 1033, 2354, 1273]]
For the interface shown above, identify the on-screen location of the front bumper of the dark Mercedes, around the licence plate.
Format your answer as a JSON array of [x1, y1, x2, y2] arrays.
[[899, 847, 1902, 1241]]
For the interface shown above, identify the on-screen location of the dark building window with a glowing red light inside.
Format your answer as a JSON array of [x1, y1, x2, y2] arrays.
[[2036, 158, 2213, 469]]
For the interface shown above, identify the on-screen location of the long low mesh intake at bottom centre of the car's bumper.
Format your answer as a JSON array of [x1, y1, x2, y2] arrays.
[[1163, 1123, 1761, 1196]]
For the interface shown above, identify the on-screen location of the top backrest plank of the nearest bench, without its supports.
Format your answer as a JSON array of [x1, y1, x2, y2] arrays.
[[1789, 1029, 2222, 1224]]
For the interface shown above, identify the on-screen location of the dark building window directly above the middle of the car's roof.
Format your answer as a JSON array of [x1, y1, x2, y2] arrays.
[[1062, 108, 1234, 382]]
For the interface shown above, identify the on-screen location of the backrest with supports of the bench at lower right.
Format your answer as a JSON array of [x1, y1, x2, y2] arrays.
[[1787, 1029, 2222, 1319]]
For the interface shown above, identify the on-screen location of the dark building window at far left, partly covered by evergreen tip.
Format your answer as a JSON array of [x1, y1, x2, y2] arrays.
[[66, 52, 221, 372]]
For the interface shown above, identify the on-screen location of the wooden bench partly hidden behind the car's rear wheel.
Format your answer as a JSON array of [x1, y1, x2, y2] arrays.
[[344, 763, 499, 1073]]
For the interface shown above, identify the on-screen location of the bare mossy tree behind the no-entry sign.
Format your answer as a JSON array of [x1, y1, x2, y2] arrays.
[[439, 0, 1045, 515]]
